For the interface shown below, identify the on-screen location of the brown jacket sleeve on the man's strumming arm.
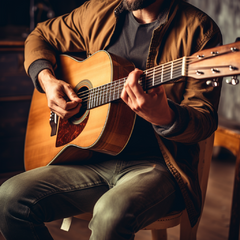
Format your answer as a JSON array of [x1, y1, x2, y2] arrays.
[[24, 3, 87, 74]]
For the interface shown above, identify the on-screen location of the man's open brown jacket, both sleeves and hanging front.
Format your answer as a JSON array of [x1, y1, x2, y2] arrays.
[[25, 0, 222, 226]]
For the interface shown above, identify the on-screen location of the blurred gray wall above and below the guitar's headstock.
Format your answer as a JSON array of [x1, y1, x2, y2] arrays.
[[188, 0, 240, 124]]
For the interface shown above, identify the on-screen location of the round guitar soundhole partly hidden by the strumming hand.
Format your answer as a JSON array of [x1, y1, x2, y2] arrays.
[[69, 86, 89, 124]]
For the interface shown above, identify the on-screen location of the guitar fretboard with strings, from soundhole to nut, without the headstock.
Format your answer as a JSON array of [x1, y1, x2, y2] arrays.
[[79, 57, 187, 109]]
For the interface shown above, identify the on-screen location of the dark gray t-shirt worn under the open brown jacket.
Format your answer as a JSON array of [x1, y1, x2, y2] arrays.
[[106, 12, 162, 159]]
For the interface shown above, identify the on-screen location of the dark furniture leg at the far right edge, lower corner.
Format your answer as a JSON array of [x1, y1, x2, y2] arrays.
[[228, 151, 240, 240]]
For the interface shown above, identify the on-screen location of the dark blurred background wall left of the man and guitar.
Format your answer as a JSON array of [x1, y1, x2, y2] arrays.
[[0, 0, 85, 174]]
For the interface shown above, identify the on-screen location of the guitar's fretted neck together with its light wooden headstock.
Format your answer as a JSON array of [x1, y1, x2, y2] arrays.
[[79, 42, 240, 109]]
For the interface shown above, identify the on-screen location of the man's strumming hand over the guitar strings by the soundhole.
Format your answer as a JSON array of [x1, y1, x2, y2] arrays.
[[38, 69, 82, 119]]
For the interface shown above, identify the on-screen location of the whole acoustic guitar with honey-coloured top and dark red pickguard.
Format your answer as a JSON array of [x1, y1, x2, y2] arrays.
[[24, 42, 240, 170]]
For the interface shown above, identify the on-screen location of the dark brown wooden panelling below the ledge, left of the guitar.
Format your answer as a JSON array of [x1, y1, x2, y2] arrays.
[[0, 42, 33, 173]]
